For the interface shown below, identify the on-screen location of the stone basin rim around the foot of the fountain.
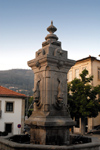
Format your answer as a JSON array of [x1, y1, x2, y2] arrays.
[[0, 137, 100, 150]]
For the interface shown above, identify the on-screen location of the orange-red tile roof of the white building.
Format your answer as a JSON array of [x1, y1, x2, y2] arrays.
[[0, 86, 27, 98]]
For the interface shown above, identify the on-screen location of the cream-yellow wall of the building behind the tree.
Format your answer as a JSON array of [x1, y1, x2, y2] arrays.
[[67, 57, 100, 133]]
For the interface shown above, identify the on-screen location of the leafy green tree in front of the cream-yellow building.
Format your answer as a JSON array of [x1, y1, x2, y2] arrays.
[[68, 69, 100, 134]]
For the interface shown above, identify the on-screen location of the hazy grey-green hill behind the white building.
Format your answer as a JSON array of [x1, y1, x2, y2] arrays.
[[0, 69, 34, 96]]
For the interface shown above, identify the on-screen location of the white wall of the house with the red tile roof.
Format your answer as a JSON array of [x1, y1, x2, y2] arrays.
[[0, 97, 23, 134]]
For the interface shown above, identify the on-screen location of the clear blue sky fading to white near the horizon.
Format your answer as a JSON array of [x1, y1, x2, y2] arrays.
[[0, 0, 100, 70]]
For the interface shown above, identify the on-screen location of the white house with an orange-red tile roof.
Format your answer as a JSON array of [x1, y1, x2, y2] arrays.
[[0, 86, 26, 134]]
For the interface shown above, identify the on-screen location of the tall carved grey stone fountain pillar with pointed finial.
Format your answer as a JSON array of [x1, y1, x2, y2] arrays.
[[25, 22, 75, 145]]
